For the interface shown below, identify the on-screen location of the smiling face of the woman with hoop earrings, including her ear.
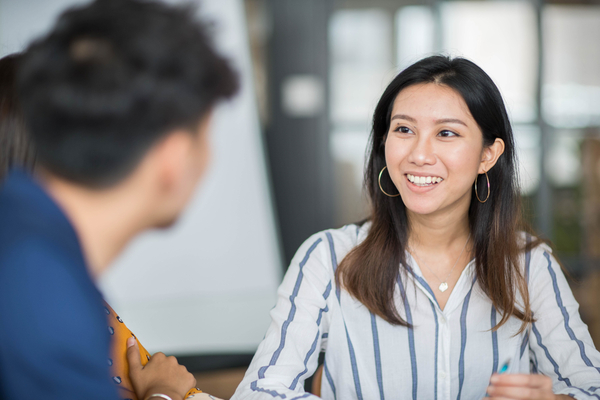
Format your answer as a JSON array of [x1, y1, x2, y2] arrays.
[[385, 83, 504, 215]]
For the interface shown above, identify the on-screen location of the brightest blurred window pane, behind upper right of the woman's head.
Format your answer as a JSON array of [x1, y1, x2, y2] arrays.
[[440, 1, 538, 123]]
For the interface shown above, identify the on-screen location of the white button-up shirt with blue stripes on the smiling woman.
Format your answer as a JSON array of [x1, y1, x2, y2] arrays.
[[232, 224, 600, 400]]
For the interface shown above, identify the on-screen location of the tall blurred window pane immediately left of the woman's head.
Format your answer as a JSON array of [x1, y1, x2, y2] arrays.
[[329, 9, 396, 225]]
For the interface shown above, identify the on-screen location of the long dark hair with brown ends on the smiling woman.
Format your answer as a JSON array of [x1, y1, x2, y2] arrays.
[[336, 56, 533, 330]]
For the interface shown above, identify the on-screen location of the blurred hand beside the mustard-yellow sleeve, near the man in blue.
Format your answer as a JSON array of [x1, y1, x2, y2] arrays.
[[127, 337, 196, 400]]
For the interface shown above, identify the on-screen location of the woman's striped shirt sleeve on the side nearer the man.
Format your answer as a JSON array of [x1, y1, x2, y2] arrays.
[[232, 234, 333, 400]]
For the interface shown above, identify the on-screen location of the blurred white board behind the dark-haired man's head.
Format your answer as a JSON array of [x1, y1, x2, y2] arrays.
[[0, 0, 283, 355]]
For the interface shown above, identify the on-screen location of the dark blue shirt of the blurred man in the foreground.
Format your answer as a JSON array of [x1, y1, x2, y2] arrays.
[[0, 171, 117, 400]]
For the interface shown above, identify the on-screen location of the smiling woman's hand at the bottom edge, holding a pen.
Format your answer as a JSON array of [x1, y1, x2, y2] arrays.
[[487, 374, 572, 400]]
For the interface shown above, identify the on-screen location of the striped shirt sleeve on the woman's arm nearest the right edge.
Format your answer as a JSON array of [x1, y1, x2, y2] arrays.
[[526, 246, 600, 399]]
